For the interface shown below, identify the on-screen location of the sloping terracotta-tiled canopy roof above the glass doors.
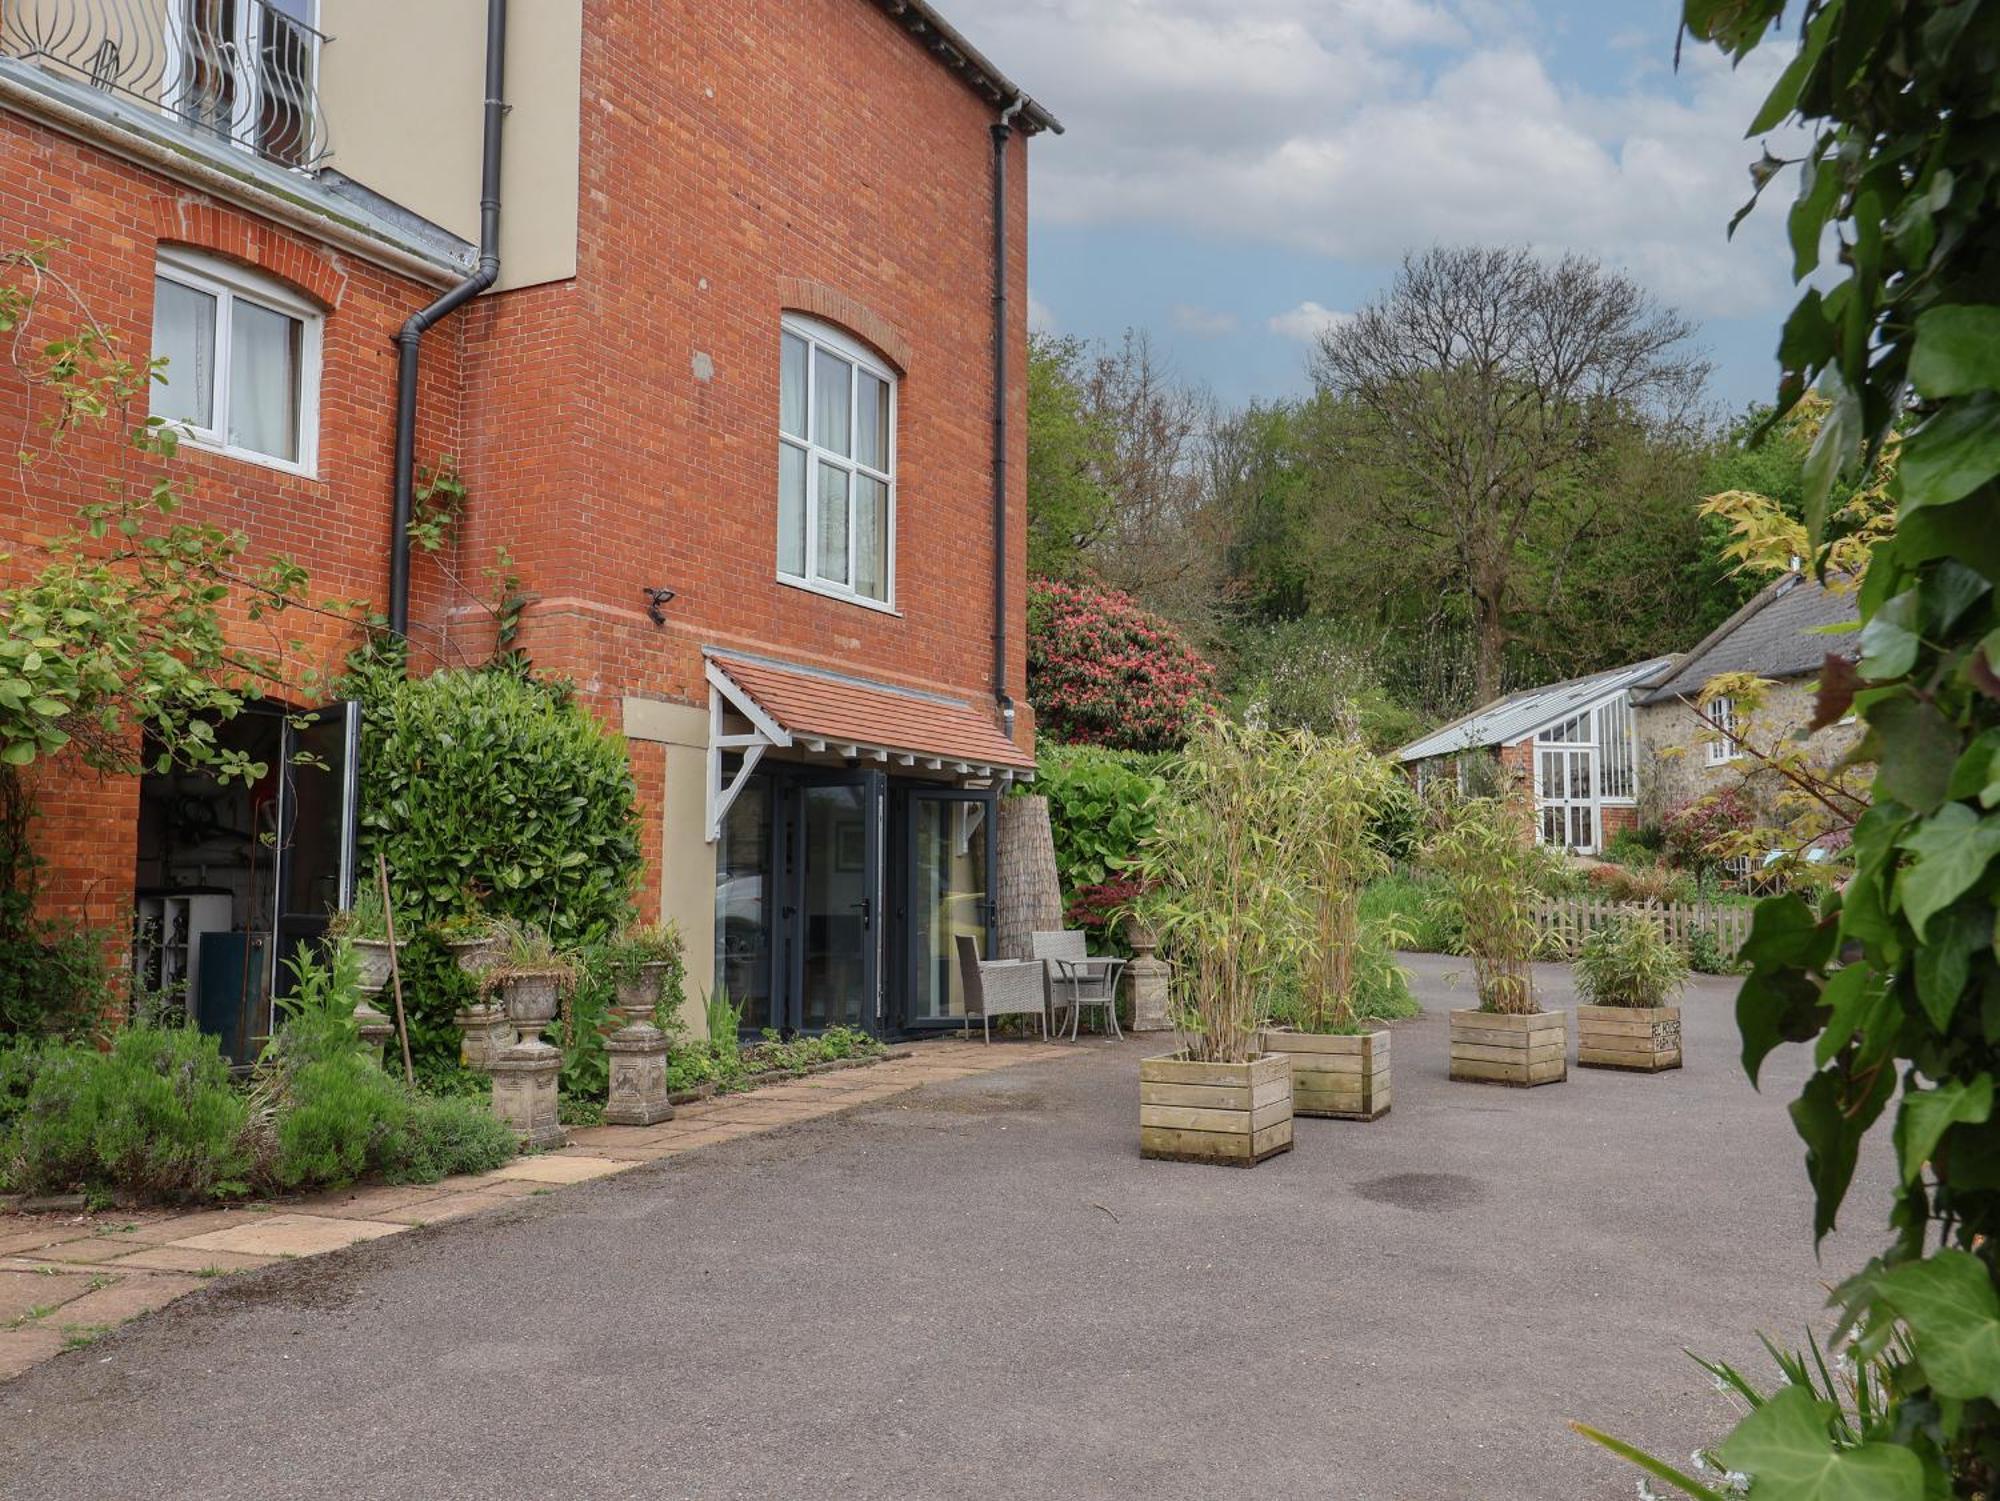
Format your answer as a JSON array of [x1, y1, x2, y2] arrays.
[[710, 650, 1034, 769]]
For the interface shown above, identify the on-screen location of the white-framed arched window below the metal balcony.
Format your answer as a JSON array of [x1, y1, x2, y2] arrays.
[[152, 250, 320, 474]]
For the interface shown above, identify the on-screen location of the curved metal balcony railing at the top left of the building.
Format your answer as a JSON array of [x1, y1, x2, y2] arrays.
[[0, 0, 328, 168]]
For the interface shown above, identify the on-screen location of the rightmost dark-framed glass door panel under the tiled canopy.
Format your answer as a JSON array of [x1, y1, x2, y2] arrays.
[[904, 793, 994, 1025]]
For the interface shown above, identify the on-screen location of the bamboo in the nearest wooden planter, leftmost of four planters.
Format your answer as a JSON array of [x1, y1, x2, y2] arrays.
[[1138, 718, 1296, 1167]]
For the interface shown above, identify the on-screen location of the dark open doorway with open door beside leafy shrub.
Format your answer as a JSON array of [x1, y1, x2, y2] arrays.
[[132, 704, 360, 1065]]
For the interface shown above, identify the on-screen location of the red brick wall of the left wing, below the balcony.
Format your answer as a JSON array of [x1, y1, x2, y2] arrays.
[[0, 114, 460, 923]]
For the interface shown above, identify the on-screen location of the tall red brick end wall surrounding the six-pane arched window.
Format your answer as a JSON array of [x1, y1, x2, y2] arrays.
[[452, 0, 1026, 724]]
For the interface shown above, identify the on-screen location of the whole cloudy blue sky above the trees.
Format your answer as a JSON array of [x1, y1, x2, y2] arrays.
[[942, 0, 1792, 418]]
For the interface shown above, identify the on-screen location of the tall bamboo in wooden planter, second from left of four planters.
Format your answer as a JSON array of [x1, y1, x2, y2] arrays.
[[1262, 730, 1396, 1121]]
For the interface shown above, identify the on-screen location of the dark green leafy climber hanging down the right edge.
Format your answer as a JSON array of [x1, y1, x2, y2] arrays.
[[1584, 0, 2000, 1501]]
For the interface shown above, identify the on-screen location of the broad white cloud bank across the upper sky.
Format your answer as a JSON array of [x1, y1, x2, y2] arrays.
[[964, 0, 1786, 316]]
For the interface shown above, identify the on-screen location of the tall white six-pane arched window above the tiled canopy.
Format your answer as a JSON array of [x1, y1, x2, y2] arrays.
[[778, 316, 896, 608]]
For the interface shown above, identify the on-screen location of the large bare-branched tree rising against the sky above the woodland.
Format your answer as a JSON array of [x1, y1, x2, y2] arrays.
[[1312, 248, 1708, 700]]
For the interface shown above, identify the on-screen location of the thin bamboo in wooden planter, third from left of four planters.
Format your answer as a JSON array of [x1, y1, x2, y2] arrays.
[[1424, 797, 1570, 1089]]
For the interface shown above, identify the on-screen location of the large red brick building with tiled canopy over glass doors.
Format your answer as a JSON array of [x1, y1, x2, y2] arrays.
[[0, 0, 1060, 1029]]
